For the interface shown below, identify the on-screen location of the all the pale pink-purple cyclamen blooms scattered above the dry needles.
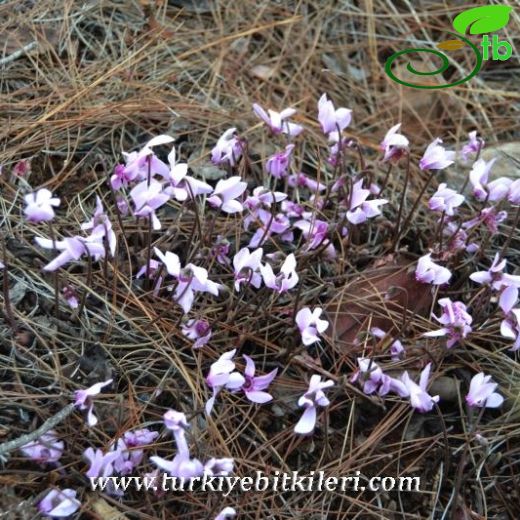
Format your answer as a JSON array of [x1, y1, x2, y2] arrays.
[[14, 94, 520, 519]]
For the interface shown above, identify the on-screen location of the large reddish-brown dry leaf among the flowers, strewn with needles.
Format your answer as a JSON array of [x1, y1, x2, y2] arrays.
[[325, 256, 432, 350]]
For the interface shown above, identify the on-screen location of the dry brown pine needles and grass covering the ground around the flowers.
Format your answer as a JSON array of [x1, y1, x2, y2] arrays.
[[0, 0, 520, 520]]
